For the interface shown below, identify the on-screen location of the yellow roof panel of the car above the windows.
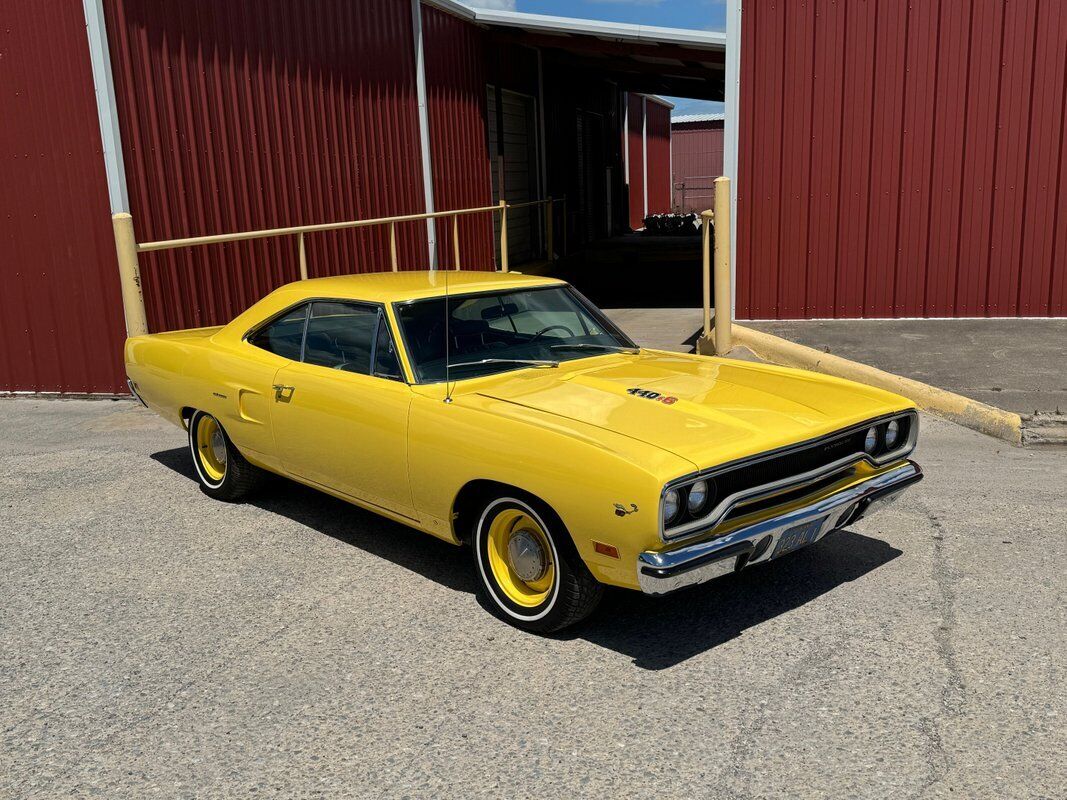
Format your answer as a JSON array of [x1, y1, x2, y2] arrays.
[[266, 270, 566, 303]]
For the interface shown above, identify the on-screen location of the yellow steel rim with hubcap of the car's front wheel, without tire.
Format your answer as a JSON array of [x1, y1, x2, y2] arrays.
[[485, 508, 557, 608]]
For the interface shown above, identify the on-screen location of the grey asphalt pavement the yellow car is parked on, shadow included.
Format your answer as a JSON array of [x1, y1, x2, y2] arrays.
[[0, 400, 1067, 798]]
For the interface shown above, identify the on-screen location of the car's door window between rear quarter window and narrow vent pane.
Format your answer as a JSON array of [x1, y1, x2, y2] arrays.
[[304, 303, 378, 375]]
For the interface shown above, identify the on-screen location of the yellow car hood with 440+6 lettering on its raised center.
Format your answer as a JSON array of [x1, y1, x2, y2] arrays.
[[476, 351, 912, 468]]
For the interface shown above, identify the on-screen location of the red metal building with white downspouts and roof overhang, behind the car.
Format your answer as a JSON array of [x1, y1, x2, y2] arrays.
[[0, 0, 724, 394]]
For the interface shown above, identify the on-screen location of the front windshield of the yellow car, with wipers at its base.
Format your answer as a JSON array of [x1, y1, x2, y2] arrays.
[[397, 286, 634, 383]]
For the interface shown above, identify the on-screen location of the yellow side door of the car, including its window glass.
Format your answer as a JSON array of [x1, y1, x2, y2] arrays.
[[271, 301, 415, 518]]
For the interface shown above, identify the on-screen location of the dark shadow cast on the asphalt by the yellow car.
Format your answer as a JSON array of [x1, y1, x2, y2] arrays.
[[152, 447, 902, 670]]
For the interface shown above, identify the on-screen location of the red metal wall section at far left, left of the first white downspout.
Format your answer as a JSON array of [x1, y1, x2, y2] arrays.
[[0, 0, 126, 394]]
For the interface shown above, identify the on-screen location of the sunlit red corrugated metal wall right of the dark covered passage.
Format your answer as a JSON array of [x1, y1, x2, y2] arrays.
[[737, 0, 1067, 318]]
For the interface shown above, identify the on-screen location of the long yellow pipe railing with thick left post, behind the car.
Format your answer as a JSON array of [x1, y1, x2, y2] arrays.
[[111, 197, 567, 336]]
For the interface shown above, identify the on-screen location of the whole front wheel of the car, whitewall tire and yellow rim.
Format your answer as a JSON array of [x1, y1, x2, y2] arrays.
[[472, 497, 604, 634]]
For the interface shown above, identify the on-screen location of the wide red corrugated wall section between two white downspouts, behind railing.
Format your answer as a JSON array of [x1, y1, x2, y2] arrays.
[[105, 0, 427, 331]]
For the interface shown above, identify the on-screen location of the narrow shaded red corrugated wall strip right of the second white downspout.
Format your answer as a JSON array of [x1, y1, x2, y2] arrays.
[[423, 4, 496, 270]]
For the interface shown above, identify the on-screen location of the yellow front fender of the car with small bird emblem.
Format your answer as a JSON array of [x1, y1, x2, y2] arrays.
[[409, 395, 694, 589]]
